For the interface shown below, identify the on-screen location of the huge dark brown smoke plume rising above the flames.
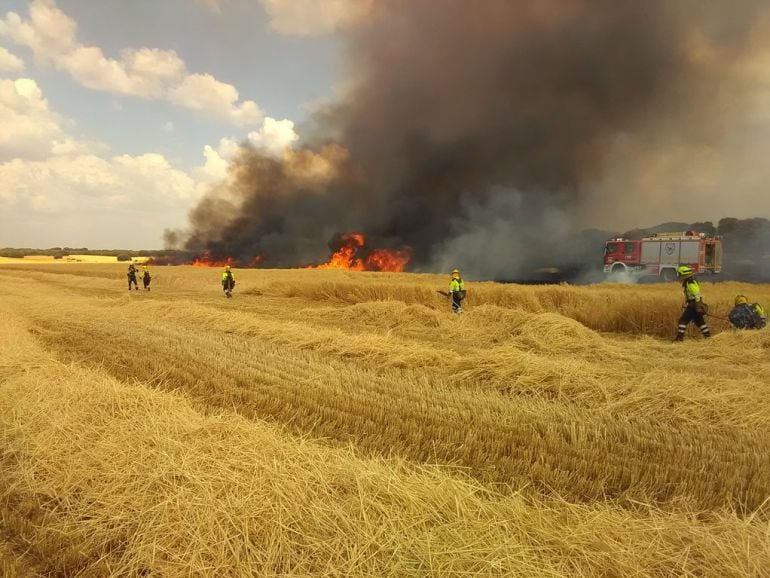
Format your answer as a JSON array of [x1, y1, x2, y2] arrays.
[[177, 0, 770, 276]]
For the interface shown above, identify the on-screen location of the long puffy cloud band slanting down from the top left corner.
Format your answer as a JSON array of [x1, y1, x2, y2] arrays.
[[0, 0, 263, 126]]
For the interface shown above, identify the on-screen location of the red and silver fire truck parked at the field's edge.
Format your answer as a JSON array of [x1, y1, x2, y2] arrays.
[[604, 231, 722, 281]]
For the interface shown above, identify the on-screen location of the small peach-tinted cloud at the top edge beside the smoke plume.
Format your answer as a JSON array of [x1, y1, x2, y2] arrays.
[[262, 0, 374, 36]]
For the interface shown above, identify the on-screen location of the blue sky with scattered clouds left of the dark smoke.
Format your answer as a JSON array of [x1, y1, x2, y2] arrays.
[[0, 0, 352, 248]]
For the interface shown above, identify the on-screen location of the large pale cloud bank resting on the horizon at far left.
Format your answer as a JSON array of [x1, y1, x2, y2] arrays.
[[0, 78, 214, 248]]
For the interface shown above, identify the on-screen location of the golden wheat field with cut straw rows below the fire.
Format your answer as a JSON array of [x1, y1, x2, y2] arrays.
[[0, 264, 770, 577]]
